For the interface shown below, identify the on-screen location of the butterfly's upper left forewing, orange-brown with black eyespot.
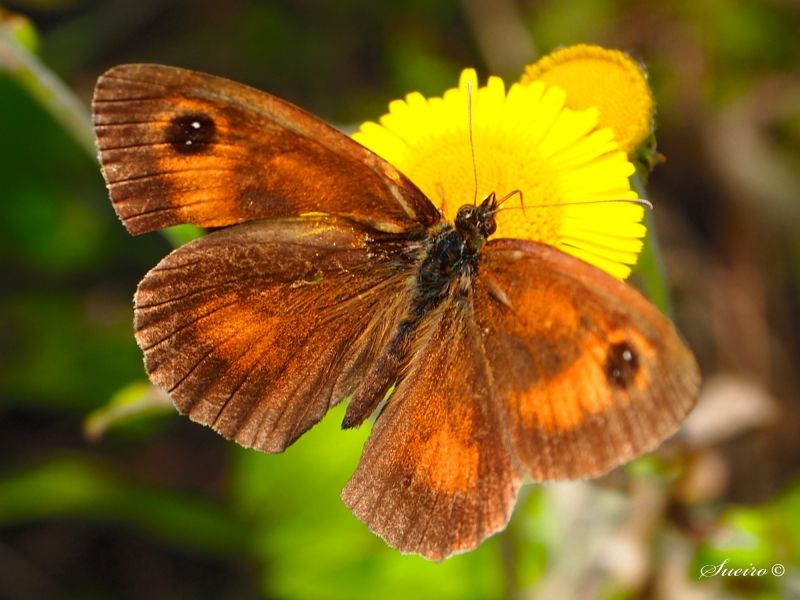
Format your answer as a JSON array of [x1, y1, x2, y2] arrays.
[[92, 65, 439, 233]]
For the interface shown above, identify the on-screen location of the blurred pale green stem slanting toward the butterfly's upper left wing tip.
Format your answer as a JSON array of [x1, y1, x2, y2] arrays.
[[0, 21, 97, 160]]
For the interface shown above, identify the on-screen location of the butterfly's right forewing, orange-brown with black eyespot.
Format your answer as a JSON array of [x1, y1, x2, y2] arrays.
[[474, 240, 700, 481]]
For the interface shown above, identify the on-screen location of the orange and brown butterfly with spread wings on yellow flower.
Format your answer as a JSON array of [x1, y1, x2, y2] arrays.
[[93, 65, 700, 561]]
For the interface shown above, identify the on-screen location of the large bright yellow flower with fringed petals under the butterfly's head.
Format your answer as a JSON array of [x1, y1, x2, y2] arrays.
[[353, 52, 646, 279]]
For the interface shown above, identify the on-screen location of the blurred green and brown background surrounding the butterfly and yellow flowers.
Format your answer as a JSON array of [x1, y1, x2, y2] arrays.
[[0, 0, 800, 600]]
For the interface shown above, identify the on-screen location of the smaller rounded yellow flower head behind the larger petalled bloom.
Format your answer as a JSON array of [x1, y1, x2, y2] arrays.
[[521, 44, 655, 154]]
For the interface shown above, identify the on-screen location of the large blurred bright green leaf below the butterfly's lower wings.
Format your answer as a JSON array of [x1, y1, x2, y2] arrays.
[[231, 405, 504, 600]]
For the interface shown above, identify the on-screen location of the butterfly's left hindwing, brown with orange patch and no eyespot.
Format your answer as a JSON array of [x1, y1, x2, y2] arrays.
[[135, 217, 413, 452]]
